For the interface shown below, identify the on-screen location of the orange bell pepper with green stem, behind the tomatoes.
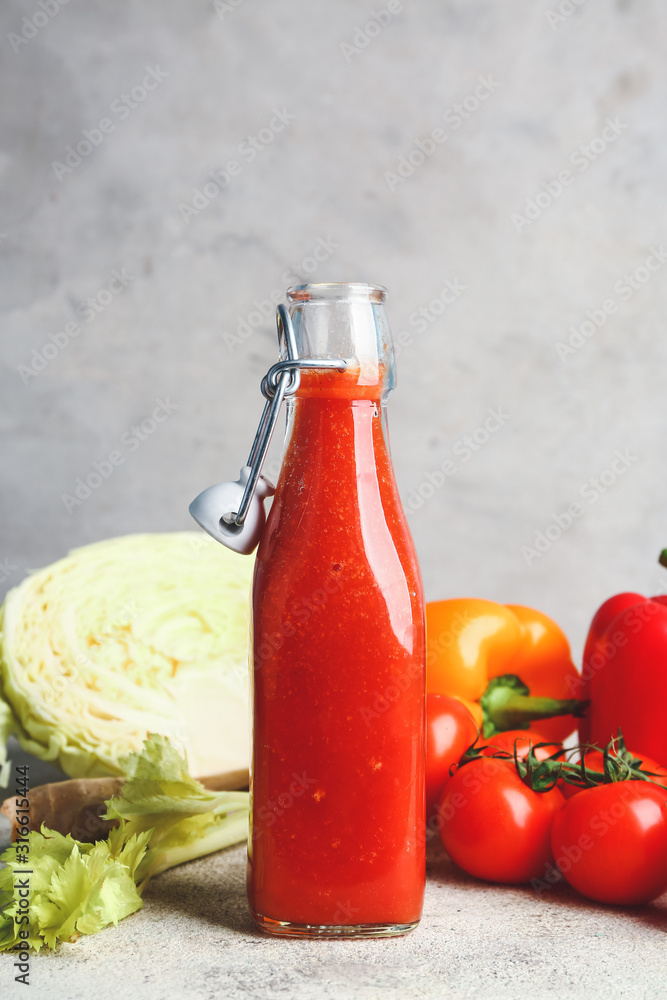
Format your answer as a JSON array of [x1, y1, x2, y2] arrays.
[[426, 598, 587, 743]]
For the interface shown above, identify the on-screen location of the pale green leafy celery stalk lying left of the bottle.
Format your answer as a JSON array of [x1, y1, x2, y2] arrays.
[[0, 735, 249, 951]]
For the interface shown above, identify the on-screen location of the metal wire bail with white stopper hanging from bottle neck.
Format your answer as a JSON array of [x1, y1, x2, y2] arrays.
[[189, 305, 347, 555]]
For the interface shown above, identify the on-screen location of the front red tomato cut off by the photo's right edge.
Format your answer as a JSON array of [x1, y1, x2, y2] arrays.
[[551, 781, 667, 905]]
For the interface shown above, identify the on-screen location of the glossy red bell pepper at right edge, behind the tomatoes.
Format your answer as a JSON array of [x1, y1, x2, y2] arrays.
[[572, 550, 667, 766]]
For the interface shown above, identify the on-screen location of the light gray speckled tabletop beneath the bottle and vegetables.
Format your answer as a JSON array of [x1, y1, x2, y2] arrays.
[[0, 744, 667, 1000]]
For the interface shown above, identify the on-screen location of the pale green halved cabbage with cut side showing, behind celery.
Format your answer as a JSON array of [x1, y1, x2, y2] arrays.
[[0, 531, 253, 778]]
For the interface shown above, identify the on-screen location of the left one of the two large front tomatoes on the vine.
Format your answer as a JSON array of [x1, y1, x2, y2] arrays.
[[438, 757, 564, 883]]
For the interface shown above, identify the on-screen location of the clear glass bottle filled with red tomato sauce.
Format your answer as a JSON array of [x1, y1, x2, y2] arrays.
[[248, 284, 425, 937]]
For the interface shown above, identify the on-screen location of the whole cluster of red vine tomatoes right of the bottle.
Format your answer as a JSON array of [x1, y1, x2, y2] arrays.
[[426, 695, 667, 905]]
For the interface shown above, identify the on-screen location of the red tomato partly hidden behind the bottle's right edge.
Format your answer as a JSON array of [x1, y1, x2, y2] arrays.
[[426, 694, 477, 819]]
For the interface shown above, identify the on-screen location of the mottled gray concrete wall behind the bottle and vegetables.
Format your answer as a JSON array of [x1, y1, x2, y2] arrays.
[[0, 0, 667, 649]]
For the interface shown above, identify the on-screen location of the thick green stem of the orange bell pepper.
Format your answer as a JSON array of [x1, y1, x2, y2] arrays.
[[480, 674, 588, 738]]
